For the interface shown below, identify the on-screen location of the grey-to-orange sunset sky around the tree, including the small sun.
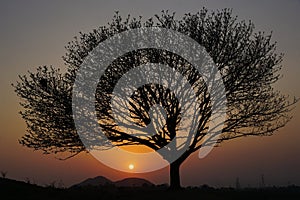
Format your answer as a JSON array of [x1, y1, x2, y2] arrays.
[[0, 0, 300, 186]]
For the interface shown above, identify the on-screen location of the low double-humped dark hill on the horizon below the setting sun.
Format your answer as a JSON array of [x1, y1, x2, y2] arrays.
[[72, 176, 154, 188]]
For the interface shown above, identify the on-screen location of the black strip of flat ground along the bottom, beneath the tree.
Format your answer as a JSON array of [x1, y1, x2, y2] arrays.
[[0, 178, 300, 200]]
